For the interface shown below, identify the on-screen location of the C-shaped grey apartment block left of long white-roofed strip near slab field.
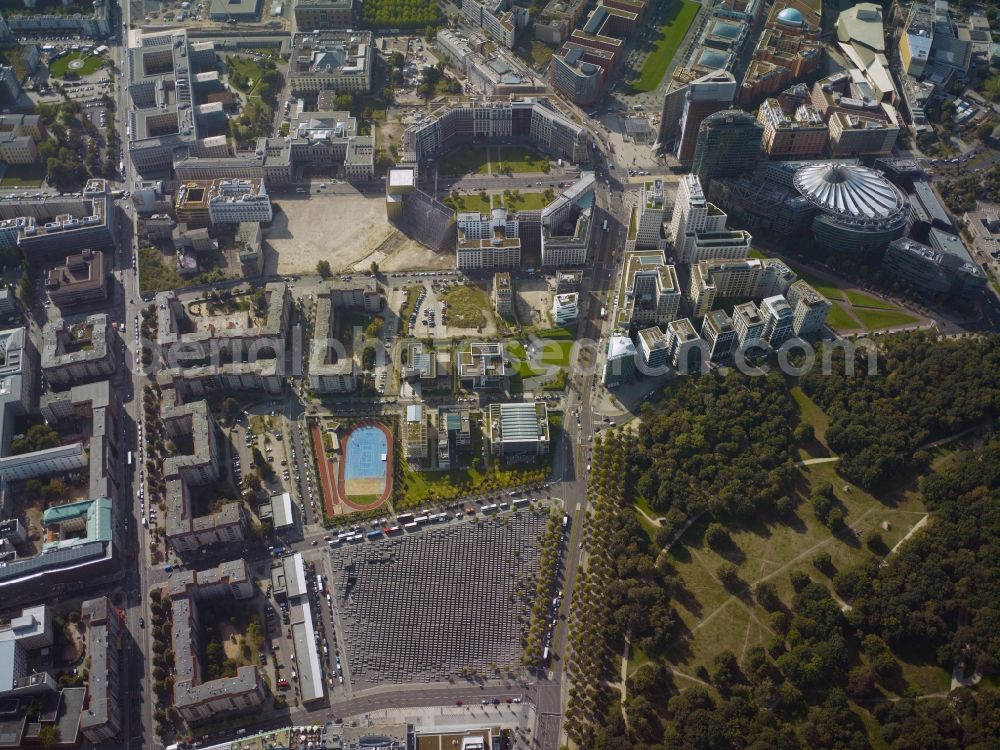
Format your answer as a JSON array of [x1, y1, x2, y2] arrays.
[[167, 560, 267, 723]]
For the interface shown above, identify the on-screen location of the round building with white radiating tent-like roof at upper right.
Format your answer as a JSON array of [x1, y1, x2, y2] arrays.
[[792, 163, 909, 253]]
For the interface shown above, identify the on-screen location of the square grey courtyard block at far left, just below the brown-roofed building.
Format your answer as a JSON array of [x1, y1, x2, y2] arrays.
[[41, 313, 118, 390]]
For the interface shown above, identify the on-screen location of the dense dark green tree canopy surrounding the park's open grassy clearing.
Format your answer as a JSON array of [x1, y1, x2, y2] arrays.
[[580, 334, 1000, 750]]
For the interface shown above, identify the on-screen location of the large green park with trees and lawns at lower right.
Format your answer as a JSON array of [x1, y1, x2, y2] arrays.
[[557, 333, 1000, 750]]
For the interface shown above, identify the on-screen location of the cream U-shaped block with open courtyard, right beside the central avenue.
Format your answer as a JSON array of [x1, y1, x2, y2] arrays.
[[612, 250, 681, 330]]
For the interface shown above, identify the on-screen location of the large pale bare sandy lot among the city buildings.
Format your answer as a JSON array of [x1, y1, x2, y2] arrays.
[[264, 194, 455, 274]]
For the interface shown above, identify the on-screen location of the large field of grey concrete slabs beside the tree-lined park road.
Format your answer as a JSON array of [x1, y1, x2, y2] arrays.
[[331, 510, 548, 689]]
